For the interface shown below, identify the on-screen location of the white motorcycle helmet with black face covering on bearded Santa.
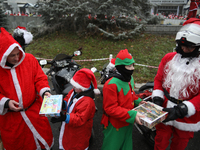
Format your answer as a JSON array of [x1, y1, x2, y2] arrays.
[[175, 20, 200, 58]]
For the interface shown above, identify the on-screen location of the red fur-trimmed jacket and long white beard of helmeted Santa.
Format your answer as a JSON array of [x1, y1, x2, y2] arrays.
[[152, 52, 200, 132]]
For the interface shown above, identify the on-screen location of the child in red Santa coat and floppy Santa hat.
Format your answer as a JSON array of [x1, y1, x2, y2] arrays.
[[51, 68, 100, 150]]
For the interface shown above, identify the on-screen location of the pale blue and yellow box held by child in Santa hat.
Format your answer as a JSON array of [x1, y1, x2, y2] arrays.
[[39, 95, 63, 117]]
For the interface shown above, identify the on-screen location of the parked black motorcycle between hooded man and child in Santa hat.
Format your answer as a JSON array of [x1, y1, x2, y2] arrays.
[[39, 48, 82, 96]]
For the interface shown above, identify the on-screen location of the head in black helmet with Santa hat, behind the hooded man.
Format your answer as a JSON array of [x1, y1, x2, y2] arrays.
[[13, 26, 33, 52]]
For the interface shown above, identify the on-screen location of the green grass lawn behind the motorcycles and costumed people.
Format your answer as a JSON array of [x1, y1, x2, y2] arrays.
[[26, 31, 175, 83]]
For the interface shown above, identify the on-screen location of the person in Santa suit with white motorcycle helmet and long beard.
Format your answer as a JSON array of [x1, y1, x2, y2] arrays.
[[152, 18, 200, 150]]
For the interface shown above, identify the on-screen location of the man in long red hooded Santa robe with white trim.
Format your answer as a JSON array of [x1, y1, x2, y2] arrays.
[[0, 27, 53, 150]]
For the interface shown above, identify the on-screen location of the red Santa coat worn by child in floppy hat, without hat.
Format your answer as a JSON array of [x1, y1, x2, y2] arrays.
[[59, 89, 95, 150]]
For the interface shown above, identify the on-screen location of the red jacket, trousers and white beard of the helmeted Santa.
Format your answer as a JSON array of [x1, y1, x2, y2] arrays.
[[152, 52, 200, 150]]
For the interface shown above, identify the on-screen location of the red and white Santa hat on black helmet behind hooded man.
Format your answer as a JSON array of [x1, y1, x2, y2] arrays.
[[14, 26, 33, 44]]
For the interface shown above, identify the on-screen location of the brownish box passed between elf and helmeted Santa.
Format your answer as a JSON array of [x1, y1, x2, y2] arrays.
[[134, 102, 168, 129]]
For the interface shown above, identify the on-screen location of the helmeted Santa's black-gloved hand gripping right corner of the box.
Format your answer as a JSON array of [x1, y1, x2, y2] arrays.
[[163, 103, 188, 122]]
